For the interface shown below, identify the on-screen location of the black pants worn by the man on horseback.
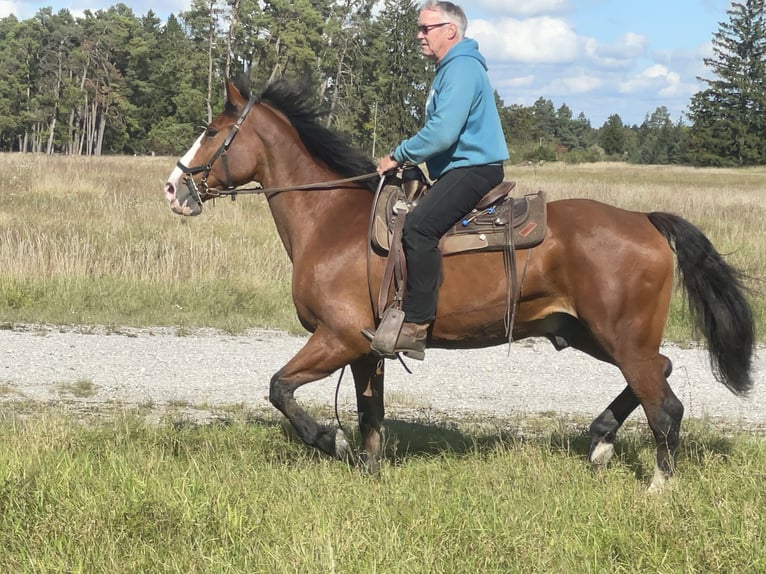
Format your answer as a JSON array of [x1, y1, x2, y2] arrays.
[[402, 165, 503, 323]]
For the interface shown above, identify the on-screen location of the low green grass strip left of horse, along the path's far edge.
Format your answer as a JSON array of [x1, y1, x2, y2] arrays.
[[0, 276, 304, 333]]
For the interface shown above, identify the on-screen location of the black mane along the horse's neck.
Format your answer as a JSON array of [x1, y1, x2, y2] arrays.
[[261, 80, 378, 191]]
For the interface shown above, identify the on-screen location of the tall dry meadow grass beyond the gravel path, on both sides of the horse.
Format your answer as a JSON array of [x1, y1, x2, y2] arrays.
[[0, 154, 766, 340]]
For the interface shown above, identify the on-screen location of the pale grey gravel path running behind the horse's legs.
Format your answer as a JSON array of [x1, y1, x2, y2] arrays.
[[0, 325, 766, 427]]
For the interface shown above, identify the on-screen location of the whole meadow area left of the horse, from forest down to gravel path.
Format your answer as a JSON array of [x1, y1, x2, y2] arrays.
[[0, 155, 297, 330]]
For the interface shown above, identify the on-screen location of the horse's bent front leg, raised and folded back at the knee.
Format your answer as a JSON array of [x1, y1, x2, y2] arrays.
[[269, 328, 361, 460]]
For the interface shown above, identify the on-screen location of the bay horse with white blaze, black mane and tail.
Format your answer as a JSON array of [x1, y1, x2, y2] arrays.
[[164, 80, 755, 489]]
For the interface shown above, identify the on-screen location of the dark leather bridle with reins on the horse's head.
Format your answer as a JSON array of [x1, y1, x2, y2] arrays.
[[176, 96, 378, 207]]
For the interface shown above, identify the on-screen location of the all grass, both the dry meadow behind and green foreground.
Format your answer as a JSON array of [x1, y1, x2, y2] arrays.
[[0, 155, 766, 574]]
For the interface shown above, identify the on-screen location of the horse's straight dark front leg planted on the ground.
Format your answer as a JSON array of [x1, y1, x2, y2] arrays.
[[351, 355, 385, 474]]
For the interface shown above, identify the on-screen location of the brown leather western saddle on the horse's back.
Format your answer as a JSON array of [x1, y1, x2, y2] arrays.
[[372, 179, 546, 255]]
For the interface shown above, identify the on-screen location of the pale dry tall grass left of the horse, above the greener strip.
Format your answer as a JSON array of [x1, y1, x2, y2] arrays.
[[0, 155, 287, 284]]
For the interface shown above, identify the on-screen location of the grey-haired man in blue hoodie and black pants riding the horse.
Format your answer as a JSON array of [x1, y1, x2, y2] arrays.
[[363, 0, 508, 360]]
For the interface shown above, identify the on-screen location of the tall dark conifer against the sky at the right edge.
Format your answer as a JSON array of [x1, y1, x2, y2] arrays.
[[687, 0, 766, 166]]
